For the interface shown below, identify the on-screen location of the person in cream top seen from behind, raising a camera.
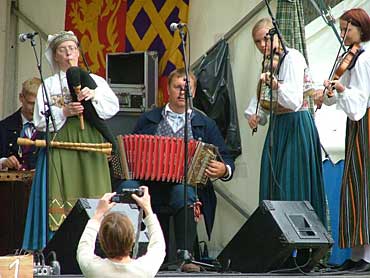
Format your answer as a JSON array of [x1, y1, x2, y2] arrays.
[[77, 186, 166, 277]]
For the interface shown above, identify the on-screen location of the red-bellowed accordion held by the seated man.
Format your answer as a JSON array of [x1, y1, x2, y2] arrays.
[[113, 134, 218, 186]]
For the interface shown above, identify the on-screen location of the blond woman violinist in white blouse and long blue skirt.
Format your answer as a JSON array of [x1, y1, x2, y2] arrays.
[[244, 18, 327, 226]]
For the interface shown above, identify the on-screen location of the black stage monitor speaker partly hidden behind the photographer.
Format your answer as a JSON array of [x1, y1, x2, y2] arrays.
[[43, 198, 148, 274]]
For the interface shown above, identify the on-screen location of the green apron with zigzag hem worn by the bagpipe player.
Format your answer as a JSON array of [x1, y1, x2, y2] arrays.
[[48, 117, 111, 231]]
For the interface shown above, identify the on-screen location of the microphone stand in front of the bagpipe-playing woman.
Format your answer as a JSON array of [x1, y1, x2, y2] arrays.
[[30, 35, 56, 243]]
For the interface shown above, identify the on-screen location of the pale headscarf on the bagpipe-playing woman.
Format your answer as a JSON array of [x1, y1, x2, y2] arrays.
[[45, 31, 78, 74]]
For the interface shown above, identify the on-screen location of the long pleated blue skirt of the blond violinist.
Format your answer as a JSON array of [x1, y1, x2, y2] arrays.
[[260, 111, 328, 227]]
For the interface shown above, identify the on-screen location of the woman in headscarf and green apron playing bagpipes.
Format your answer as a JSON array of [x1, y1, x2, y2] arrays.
[[23, 31, 119, 250]]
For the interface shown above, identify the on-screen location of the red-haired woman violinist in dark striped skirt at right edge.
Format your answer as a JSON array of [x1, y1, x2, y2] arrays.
[[316, 8, 370, 272]]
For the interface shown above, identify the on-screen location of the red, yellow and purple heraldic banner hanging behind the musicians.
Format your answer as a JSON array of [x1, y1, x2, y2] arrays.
[[65, 0, 190, 106]]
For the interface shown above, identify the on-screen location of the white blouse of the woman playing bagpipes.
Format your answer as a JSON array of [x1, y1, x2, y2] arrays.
[[33, 71, 119, 131]]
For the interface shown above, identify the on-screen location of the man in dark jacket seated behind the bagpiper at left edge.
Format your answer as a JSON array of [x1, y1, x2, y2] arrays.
[[0, 77, 41, 171]]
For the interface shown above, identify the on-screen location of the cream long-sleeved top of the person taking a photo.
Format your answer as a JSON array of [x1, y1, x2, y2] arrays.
[[77, 214, 166, 278]]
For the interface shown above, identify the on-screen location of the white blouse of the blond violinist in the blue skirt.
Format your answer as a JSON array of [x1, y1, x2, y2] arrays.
[[244, 48, 307, 125]]
